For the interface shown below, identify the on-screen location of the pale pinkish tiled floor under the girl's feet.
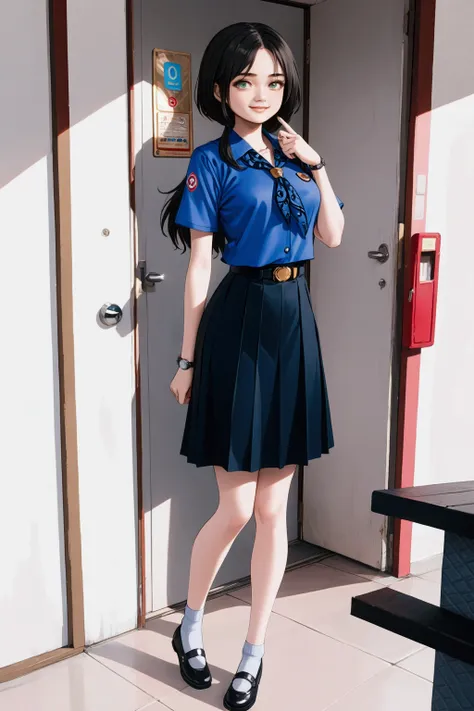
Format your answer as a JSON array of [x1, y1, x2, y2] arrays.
[[0, 556, 440, 711]]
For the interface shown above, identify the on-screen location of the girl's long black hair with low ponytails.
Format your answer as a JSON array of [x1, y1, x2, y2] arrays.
[[159, 22, 301, 256]]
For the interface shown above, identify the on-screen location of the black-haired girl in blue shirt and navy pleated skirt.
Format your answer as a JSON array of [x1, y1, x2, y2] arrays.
[[161, 22, 344, 711]]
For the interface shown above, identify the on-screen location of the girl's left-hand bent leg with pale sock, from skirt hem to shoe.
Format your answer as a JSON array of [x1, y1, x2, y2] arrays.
[[181, 466, 258, 669]]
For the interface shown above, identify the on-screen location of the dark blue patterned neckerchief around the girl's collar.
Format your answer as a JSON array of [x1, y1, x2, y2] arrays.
[[241, 146, 308, 237]]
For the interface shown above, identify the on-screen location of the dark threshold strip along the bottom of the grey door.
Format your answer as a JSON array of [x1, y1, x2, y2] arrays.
[[145, 539, 336, 620]]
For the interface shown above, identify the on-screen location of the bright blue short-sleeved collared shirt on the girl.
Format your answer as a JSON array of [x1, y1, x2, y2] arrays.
[[176, 130, 344, 267]]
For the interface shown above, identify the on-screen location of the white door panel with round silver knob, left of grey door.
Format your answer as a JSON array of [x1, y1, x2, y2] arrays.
[[68, 0, 138, 644]]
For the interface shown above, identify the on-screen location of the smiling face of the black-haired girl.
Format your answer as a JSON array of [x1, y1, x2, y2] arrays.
[[215, 49, 285, 124]]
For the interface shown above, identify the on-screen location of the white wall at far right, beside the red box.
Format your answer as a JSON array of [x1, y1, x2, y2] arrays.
[[412, 0, 474, 561]]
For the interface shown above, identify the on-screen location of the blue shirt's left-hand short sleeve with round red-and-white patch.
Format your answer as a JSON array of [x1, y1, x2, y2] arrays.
[[175, 148, 219, 232]]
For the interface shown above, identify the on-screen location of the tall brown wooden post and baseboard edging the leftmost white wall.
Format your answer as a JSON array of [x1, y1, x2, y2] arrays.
[[0, 0, 85, 683]]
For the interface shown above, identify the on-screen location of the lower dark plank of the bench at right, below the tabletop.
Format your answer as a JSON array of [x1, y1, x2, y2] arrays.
[[351, 588, 474, 665]]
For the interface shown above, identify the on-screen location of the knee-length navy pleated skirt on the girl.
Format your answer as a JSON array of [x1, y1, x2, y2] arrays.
[[180, 271, 334, 472]]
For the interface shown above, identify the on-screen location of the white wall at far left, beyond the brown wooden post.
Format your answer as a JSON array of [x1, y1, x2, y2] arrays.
[[0, 0, 68, 667]]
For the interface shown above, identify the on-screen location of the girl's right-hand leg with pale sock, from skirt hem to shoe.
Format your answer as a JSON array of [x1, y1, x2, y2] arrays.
[[232, 464, 296, 692]]
